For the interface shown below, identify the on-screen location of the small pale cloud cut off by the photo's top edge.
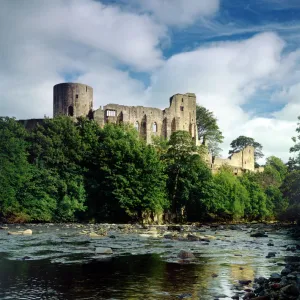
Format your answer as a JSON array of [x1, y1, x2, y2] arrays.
[[129, 0, 220, 26]]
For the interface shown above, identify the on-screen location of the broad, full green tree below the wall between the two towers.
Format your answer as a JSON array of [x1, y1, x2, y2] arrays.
[[84, 124, 168, 220]]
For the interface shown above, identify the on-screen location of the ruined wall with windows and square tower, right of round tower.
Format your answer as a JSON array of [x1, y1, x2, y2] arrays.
[[93, 94, 198, 143]]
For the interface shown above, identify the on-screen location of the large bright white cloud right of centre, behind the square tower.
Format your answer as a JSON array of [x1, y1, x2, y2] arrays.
[[149, 33, 299, 159]]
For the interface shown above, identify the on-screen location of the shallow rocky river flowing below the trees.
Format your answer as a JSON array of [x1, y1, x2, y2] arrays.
[[0, 224, 298, 300]]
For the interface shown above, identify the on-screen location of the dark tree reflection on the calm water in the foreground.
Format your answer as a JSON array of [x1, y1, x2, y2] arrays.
[[0, 254, 213, 299]]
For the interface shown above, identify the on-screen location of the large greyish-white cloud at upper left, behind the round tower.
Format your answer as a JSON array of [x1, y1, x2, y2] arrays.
[[0, 0, 166, 118]]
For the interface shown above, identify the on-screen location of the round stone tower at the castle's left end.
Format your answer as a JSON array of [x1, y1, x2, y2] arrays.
[[53, 82, 93, 118]]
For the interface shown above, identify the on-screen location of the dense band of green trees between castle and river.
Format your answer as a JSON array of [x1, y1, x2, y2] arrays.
[[0, 117, 300, 222]]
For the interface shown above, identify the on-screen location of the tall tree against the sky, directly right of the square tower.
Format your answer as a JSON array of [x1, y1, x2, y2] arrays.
[[196, 105, 224, 154]]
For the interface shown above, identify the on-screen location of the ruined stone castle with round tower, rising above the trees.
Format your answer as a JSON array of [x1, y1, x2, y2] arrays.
[[21, 83, 258, 175]]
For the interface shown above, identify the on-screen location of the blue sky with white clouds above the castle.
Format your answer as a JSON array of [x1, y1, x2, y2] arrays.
[[0, 0, 300, 161]]
